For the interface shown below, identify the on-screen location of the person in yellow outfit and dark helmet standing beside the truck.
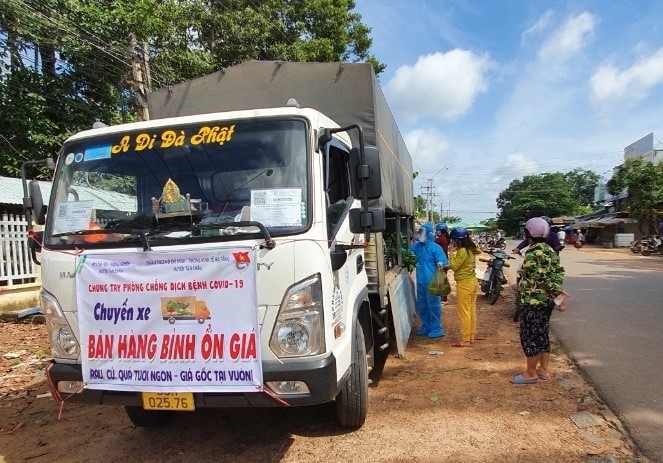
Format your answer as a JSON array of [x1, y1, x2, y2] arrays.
[[449, 227, 481, 347]]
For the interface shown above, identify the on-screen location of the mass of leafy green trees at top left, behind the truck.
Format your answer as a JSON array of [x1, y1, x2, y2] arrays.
[[0, 0, 385, 175]]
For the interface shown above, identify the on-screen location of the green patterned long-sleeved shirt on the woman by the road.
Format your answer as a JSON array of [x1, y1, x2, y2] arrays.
[[518, 243, 564, 306]]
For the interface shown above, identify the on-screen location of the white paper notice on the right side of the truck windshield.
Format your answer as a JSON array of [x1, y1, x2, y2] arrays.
[[251, 188, 302, 227]]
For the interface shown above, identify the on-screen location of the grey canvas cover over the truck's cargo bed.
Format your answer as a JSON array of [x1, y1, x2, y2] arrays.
[[148, 61, 414, 216]]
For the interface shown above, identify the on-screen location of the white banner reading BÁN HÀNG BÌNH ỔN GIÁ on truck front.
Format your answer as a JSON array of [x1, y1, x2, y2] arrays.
[[76, 248, 262, 392]]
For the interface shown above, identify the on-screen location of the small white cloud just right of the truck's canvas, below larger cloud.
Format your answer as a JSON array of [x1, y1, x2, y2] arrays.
[[404, 129, 449, 176]]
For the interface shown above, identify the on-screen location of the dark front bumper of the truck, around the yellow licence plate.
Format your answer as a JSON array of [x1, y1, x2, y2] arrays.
[[47, 355, 344, 408]]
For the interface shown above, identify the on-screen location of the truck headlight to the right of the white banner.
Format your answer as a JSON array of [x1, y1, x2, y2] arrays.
[[269, 275, 325, 357]]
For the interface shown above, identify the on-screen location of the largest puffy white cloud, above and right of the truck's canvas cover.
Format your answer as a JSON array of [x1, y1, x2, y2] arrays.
[[385, 49, 493, 122]]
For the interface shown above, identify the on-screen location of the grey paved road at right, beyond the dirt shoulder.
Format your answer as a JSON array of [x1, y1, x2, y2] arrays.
[[552, 247, 663, 462]]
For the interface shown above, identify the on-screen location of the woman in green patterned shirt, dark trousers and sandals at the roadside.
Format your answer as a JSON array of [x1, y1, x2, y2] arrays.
[[511, 217, 564, 384]]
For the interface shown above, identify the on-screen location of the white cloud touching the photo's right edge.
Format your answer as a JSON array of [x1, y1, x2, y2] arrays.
[[590, 48, 663, 102]]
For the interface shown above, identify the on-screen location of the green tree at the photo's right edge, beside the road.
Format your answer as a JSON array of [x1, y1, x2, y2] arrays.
[[606, 158, 663, 232]]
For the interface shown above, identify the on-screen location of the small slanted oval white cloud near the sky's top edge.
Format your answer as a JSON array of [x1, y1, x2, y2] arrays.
[[539, 12, 595, 60]]
